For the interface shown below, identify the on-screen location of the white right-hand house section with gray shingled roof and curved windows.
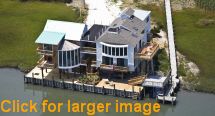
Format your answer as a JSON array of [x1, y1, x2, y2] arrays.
[[96, 8, 151, 72]]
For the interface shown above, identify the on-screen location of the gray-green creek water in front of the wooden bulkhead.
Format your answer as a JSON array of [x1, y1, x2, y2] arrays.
[[0, 68, 215, 116]]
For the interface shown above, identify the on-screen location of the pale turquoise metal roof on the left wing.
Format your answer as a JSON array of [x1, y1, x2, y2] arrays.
[[35, 31, 65, 45]]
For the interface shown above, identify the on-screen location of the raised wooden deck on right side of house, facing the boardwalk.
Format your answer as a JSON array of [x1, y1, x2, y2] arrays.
[[136, 42, 159, 60]]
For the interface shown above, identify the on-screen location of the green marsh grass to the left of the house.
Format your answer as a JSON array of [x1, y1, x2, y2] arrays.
[[0, 0, 82, 69]]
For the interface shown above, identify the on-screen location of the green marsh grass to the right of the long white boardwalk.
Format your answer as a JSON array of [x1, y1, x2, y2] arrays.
[[173, 9, 215, 93]]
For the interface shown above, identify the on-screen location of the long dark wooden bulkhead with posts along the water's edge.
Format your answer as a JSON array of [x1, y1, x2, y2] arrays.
[[24, 76, 143, 100]]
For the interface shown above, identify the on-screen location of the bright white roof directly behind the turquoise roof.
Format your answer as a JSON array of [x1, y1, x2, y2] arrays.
[[44, 20, 87, 41]]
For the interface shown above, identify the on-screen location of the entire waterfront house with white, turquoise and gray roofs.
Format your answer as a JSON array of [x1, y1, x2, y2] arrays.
[[36, 8, 168, 97]]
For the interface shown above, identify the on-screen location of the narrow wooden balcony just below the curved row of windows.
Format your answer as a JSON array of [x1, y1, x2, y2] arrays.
[[100, 64, 129, 72]]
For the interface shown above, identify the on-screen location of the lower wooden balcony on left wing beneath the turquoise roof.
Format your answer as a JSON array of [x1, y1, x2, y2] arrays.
[[37, 57, 54, 68]]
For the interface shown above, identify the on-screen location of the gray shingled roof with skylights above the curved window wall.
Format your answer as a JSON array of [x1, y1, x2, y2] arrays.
[[97, 8, 146, 47]]
